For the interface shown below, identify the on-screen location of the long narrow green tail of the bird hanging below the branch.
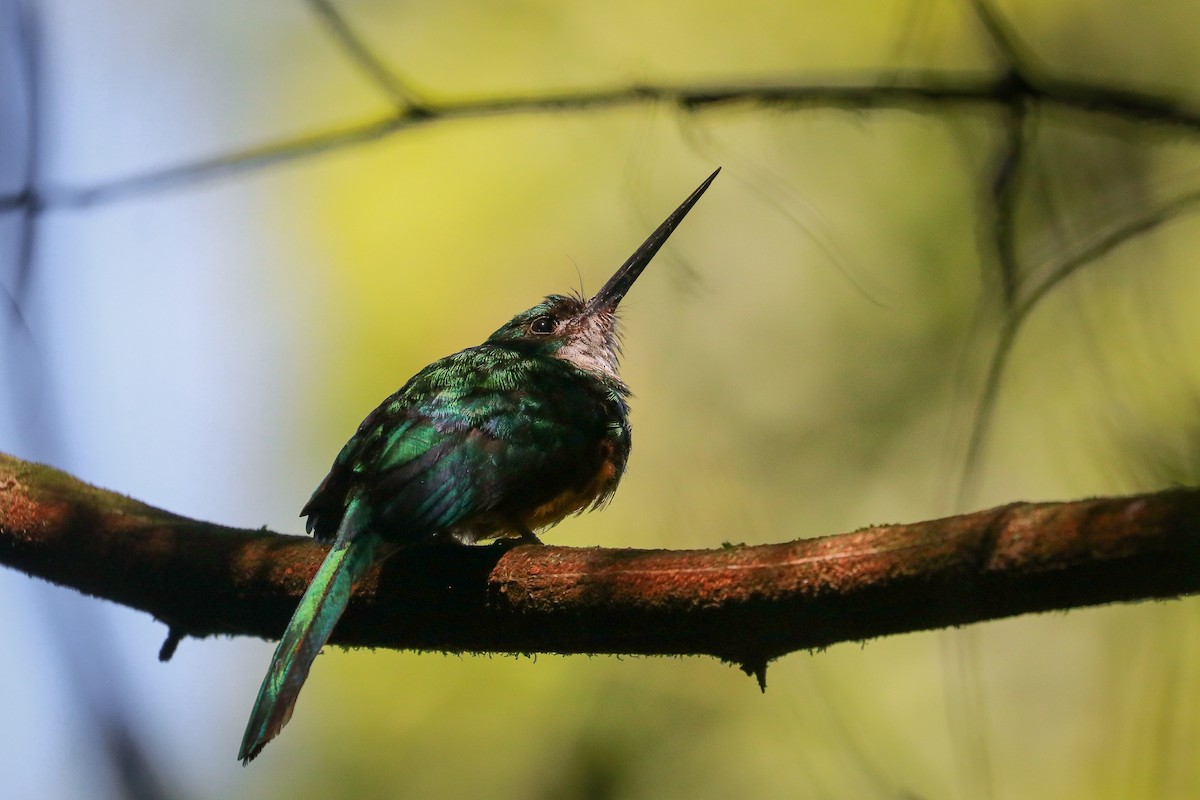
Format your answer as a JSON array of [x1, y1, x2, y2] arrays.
[[238, 509, 382, 764]]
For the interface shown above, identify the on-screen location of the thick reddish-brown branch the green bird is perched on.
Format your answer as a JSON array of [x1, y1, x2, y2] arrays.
[[0, 453, 1200, 676]]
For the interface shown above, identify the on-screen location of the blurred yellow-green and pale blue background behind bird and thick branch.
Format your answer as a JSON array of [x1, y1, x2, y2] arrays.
[[0, 0, 1200, 800]]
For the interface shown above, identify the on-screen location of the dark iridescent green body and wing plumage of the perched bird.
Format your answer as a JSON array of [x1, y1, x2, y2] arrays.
[[304, 321, 629, 543]]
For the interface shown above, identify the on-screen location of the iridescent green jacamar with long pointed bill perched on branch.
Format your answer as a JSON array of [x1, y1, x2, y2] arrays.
[[238, 169, 720, 764]]
